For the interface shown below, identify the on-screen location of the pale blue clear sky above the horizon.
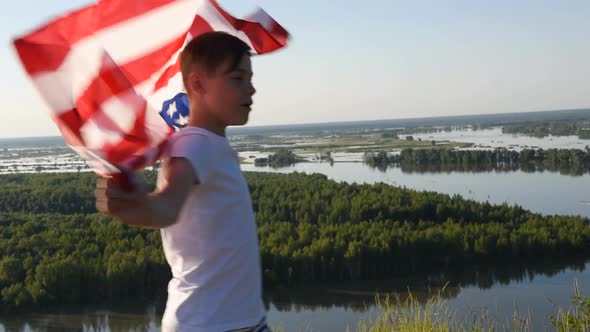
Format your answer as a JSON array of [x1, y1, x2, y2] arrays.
[[0, 0, 590, 137]]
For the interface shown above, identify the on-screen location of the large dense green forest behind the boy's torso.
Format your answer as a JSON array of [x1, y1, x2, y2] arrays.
[[0, 172, 590, 310]]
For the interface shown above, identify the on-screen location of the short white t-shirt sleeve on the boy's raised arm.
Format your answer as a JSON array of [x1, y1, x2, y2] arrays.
[[168, 134, 213, 184]]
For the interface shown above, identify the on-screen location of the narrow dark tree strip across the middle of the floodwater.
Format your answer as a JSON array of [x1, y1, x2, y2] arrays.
[[363, 148, 590, 175]]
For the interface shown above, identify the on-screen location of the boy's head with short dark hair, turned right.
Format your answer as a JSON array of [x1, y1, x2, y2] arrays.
[[180, 32, 256, 128]]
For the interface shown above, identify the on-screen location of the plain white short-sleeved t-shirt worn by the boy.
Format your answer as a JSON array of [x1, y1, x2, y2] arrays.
[[158, 127, 265, 332]]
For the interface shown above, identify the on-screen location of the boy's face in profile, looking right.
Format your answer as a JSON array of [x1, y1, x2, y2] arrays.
[[204, 55, 256, 126]]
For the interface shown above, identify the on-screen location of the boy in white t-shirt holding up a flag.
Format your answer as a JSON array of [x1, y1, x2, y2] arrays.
[[96, 32, 269, 332]]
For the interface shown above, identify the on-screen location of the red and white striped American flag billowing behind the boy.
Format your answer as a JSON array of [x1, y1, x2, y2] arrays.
[[14, 0, 289, 175]]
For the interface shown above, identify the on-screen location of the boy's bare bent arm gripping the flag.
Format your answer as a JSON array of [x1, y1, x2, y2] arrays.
[[95, 158, 197, 229]]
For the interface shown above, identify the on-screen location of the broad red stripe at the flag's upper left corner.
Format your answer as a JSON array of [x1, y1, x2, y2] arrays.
[[14, 0, 175, 75]]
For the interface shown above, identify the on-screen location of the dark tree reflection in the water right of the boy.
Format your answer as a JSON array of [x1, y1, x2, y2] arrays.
[[265, 257, 590, 311]]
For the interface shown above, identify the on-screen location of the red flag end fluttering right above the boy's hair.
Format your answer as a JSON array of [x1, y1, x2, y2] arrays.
[[210, 0, 289, 54]]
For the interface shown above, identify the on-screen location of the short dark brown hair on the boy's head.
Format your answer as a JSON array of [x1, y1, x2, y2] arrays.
[[180, 31, 250, 83]]
